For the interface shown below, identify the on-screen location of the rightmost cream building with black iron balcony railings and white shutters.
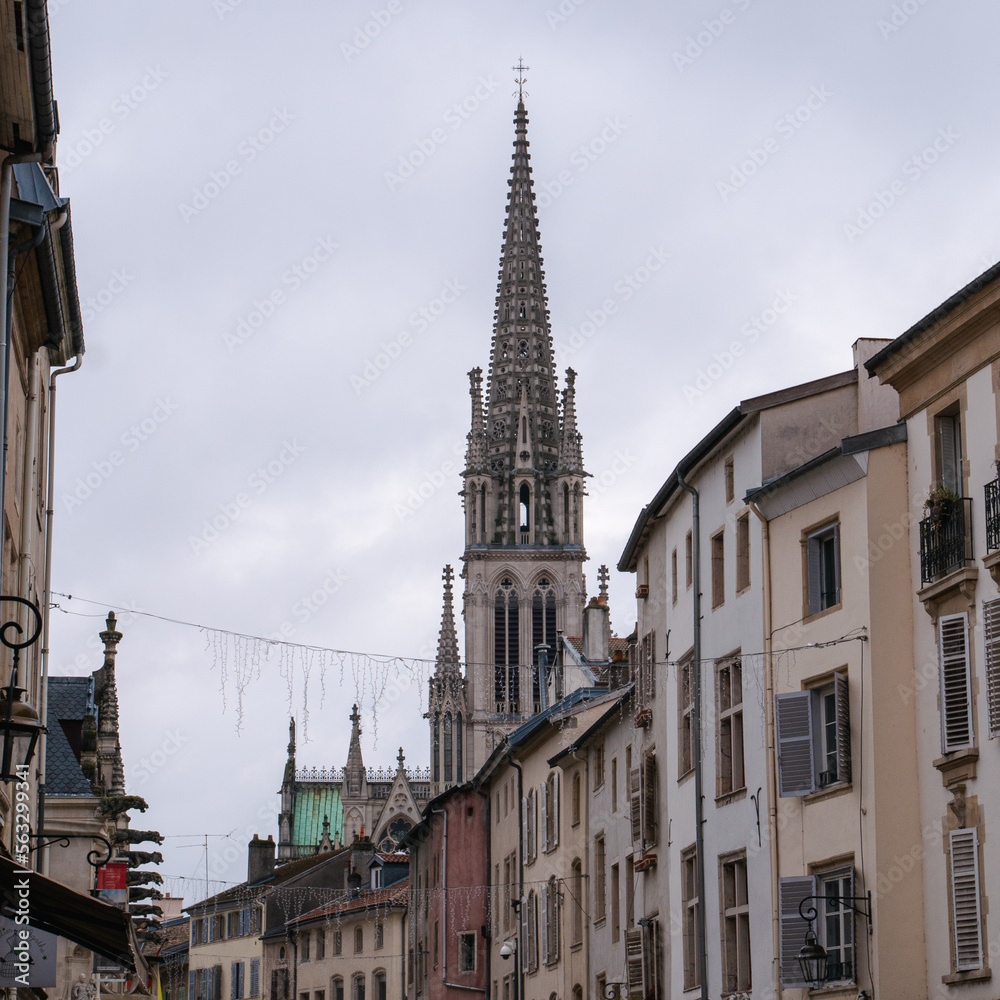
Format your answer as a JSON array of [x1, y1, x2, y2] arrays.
[[866, 265, 1000, 1000]]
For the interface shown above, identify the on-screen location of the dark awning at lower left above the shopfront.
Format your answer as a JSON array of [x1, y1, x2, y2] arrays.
[[0, 857, 149, 989]]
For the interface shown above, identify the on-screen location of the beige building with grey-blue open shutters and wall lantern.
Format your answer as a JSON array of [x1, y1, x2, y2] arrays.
[[747, 341, 927, 1000]]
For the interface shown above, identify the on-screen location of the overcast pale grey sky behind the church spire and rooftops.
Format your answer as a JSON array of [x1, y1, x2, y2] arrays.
[[43, 0, 1000, 901]]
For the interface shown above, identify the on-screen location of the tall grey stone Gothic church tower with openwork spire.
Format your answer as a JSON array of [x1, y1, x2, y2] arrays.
[[428, 88, 587, 790]]
